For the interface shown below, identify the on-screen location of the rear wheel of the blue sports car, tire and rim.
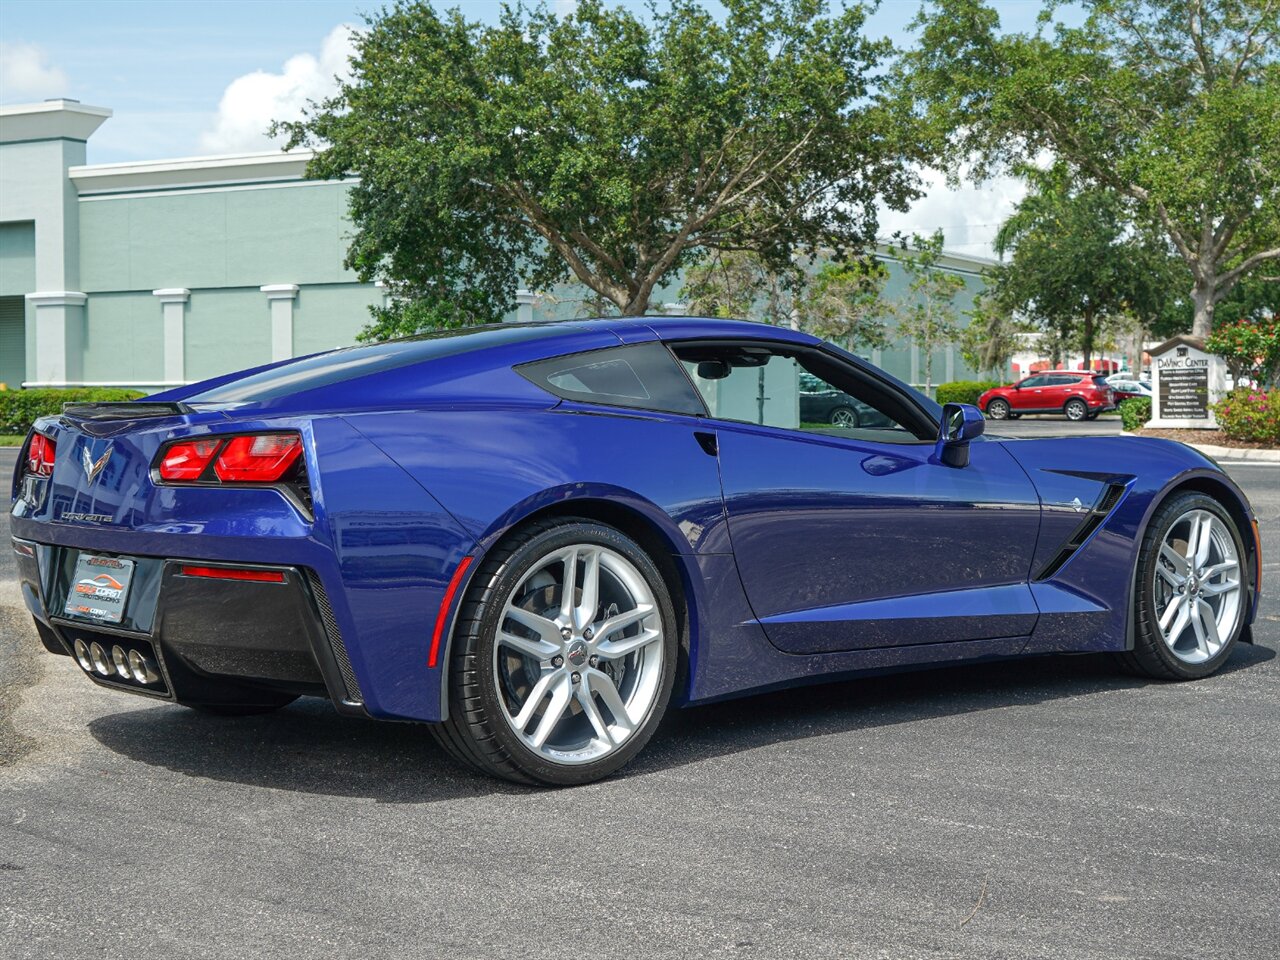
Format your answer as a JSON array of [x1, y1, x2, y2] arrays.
[[433, 520, 677, 786]]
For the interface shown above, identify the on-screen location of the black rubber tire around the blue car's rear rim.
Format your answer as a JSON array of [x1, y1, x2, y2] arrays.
[[431, 517, 680, 786]]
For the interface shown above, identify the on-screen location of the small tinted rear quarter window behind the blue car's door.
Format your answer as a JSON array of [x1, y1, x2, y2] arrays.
[[516, 343, 707, 416]]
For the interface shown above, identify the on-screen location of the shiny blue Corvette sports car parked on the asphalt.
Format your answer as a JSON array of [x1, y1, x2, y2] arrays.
[[12, 317, 1261, 785]]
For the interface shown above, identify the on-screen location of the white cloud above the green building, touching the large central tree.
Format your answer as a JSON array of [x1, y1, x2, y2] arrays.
[[200, 23, 356, 154]]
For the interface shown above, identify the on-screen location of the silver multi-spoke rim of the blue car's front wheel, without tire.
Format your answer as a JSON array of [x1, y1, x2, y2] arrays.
[[1153, 509, 1243, 663]]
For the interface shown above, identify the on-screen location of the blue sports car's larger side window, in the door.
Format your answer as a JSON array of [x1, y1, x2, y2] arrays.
[[672, 343, 937, 443]]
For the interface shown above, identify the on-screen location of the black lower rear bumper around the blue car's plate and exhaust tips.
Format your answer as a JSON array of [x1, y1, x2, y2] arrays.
[[13, 538, 365, 716]]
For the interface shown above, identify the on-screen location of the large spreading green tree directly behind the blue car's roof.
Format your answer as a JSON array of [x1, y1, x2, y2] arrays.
[[279, 0, 923, 335]]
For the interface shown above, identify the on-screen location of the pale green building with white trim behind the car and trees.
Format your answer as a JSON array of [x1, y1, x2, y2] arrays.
[[0, 100, 989, 390]]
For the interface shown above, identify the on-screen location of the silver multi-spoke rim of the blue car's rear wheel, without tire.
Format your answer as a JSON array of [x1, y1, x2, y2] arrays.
[[493, 544, 663, 764]]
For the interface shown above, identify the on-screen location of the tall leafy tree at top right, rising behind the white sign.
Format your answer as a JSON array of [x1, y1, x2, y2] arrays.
[[900, 0, 1280, 337]]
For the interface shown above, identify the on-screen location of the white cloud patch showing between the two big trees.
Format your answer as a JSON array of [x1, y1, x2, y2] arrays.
[[879, 170, 1027, 257]]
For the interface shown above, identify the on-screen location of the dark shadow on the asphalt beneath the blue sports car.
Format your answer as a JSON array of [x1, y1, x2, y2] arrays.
[[88, 645, 1276, 804]]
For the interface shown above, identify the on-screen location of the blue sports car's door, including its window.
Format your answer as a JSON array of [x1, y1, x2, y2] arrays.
[[672, 342, 1039, 653]]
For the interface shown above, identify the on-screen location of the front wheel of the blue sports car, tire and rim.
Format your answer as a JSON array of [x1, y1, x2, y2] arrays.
[[1123, 493, 1248, 680]]
